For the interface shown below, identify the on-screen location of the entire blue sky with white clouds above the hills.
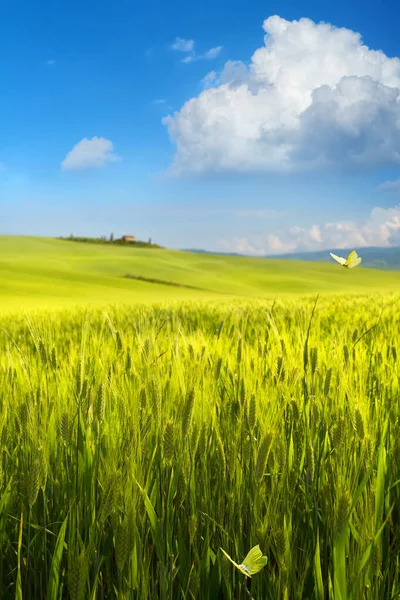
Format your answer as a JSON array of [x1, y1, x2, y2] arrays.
[[0, 0, 400, 255]]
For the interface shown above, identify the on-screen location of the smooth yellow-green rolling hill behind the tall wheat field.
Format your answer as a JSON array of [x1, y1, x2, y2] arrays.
[[0, 236, 400, 312]]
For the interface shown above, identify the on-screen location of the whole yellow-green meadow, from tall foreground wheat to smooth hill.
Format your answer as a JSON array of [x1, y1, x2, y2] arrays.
[[0, 237, 400, 600]]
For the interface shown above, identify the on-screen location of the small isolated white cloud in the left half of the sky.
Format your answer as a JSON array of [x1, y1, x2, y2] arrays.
[[61, 137, 119, 171]]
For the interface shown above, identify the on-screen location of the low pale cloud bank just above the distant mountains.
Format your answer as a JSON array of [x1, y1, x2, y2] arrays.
[[221, 205, 400, 256]]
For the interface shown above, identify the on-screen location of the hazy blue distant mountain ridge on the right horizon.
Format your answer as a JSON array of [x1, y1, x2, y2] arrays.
[[265, 246, 400, 270]]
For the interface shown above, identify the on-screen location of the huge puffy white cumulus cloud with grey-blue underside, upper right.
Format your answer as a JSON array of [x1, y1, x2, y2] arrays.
[[163, 16, 400, 175]]
